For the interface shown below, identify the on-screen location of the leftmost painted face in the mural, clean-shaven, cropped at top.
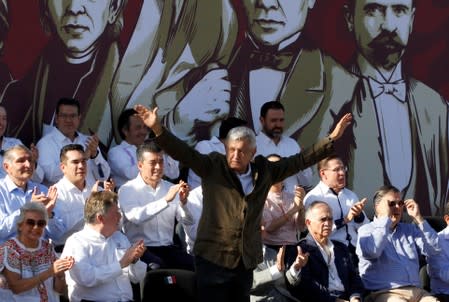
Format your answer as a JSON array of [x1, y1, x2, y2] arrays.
[[48, 0, 120, 57]]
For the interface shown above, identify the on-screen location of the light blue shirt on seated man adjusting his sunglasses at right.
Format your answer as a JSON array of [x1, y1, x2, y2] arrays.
[[356, 217, 440, 290]]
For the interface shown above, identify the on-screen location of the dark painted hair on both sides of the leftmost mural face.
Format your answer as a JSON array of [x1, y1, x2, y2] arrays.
[[39, 0, 128, 40]]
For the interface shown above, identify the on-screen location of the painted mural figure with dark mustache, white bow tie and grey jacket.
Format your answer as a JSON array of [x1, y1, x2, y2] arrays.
[[337, 0, 449, 215]]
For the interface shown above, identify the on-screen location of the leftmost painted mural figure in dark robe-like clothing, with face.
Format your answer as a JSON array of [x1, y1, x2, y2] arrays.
[[2, 0, 126, 149]]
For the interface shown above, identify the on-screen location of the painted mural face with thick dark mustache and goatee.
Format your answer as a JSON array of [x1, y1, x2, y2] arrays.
[[346, 0, 415, 69]]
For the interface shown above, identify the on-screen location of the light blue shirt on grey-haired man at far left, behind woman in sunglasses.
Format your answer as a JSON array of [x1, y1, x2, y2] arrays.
[[0, 175, 65, 243]]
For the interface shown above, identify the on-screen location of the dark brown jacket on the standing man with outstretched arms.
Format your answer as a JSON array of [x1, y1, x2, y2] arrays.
[[156, 131, 333, 269]]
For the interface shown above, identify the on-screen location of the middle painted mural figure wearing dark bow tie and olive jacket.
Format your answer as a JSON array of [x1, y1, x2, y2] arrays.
[[228, 0, 356, 145]]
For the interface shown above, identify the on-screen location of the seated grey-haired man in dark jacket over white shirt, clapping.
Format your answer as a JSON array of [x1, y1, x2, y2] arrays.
[[286, 201, 364, 302]]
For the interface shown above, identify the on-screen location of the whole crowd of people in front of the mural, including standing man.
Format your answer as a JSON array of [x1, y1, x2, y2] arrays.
[[0, 98, 449, 302]]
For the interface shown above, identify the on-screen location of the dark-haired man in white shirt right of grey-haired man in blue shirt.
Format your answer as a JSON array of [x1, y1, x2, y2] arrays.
[[54, 144, 113, 253]]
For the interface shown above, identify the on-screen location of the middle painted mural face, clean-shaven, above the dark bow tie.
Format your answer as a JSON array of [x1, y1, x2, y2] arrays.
[[243, 0, 315, 45]]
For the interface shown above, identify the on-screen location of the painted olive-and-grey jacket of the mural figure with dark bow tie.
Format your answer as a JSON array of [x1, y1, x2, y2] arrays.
[[228, 37, 358, 146]]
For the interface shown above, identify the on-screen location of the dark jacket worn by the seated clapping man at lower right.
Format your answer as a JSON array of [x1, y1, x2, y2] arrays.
[[286, 235, 364, 302]]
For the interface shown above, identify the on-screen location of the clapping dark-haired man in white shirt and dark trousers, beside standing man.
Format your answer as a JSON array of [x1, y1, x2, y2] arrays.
[[118, 141, 194, 271]]
